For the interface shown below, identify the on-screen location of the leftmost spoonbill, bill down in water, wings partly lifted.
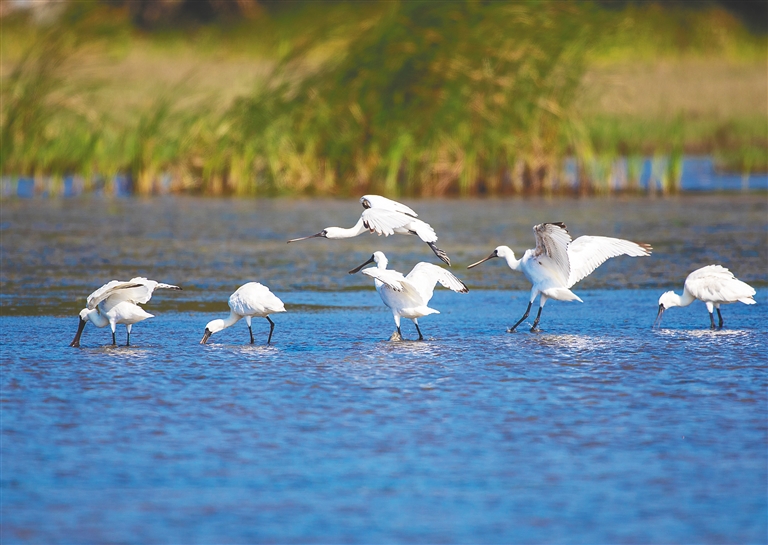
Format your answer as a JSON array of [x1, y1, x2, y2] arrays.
[[69, 276, 181, 347]]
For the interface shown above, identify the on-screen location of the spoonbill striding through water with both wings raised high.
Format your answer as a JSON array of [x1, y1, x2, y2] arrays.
[[467, 223, 652, 333]]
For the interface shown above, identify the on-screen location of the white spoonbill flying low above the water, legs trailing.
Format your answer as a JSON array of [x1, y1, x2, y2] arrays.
[[288, 195, 451, 267]]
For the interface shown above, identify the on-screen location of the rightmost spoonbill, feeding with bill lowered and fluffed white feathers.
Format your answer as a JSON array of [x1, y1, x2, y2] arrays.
[[653, 265, 755, 329]]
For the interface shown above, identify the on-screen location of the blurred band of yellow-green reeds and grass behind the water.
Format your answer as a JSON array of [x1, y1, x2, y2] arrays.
[[0, 1, 768, 196]]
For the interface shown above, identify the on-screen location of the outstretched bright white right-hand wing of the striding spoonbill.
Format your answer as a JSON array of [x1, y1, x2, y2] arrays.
[[566, 236, 652, 288]]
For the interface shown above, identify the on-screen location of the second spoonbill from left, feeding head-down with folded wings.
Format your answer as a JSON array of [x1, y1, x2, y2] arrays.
[[200, 282, 285, 344]]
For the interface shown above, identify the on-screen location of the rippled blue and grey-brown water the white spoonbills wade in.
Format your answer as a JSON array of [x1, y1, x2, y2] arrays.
[[0, 194, 768, 543]]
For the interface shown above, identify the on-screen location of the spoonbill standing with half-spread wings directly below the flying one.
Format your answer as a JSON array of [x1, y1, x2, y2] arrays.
[[349, 252, 469, 341]]
